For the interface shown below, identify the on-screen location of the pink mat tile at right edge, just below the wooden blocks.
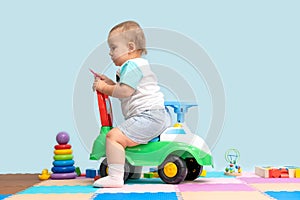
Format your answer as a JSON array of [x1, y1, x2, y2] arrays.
[[239, 177, 300, 183]]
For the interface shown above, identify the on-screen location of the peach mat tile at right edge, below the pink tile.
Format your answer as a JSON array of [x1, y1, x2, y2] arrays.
[[250, 183, 300, 192]]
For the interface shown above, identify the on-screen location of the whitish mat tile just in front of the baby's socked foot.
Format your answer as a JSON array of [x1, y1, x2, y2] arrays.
[[95, 184, 178, 193]]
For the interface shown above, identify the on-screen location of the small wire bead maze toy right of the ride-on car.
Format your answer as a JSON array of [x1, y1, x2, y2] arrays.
[[224, 149, 242, 176]]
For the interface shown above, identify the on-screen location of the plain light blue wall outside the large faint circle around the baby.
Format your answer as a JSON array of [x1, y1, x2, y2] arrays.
[[0, 0, 300, 173]]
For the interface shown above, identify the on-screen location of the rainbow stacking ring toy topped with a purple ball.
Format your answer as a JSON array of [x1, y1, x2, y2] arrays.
[[51, 132, 77, 179]]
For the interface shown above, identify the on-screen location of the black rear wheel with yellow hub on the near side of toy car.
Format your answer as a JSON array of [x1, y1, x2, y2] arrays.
[[158, 155, 187, 184]]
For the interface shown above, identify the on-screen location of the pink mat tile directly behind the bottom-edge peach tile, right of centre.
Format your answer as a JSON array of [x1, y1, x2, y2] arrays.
[[178, 183, 255, 192]]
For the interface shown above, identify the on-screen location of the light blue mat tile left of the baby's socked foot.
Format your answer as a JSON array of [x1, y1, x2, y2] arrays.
[[18, 185, 98, 194]]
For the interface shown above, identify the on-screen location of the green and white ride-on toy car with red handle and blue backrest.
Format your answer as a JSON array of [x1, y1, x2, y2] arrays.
[[90, 91, 213, 184]]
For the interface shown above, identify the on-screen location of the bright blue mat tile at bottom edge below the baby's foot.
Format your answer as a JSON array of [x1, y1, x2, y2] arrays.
[[93, 192, 178, 200]]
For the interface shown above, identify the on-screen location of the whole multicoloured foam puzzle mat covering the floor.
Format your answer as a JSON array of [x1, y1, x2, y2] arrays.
[[0, 170, 300, 200]]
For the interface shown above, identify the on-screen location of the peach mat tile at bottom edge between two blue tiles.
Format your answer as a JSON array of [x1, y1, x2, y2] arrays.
[[181, 191, 273, 200]]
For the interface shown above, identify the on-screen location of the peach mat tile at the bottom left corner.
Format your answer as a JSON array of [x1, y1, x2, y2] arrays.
[[6, 194, 93, 200]]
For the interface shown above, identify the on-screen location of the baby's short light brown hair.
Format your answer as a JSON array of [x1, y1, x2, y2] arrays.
[[109, 21, 147, 54]]
